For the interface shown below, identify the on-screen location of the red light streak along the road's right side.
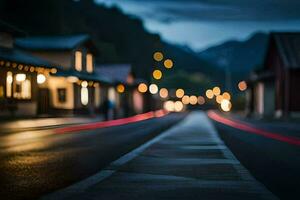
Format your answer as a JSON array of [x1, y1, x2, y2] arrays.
[[207, 111, 300, 146]]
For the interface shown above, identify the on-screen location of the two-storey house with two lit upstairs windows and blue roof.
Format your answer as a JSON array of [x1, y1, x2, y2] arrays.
[[15, 35, 109, 114]]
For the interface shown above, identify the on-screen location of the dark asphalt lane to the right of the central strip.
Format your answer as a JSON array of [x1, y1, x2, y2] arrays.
[[210, 111, 300, 199]]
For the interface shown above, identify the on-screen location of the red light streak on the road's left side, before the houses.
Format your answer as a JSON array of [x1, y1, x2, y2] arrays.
[[54, 110, 168, 134]]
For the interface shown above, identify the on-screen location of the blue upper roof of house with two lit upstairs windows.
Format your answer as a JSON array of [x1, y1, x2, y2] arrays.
[[15, 35, 90, 51]]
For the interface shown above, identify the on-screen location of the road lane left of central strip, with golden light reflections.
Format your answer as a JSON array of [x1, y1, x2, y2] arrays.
[[0, 114, 185, 199]]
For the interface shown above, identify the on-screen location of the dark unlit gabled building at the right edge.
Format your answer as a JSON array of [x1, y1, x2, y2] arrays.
[[248, 32, 300, 117]]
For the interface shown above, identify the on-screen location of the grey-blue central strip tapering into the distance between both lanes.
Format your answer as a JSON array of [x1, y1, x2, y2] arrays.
[[42, 112, 277, 200]]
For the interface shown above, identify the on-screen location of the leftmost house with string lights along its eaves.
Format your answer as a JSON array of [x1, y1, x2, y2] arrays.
[[0, 22, 58, 117]]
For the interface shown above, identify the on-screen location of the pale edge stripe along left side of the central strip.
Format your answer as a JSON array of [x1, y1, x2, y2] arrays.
[[41, 112, 185, 200]]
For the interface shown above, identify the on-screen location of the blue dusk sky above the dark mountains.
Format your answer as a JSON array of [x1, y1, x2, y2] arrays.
[[96, 0, 300, 50]]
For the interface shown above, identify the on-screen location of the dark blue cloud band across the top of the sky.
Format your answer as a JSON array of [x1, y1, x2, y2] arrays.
[[98, 0, 300, 22]]
